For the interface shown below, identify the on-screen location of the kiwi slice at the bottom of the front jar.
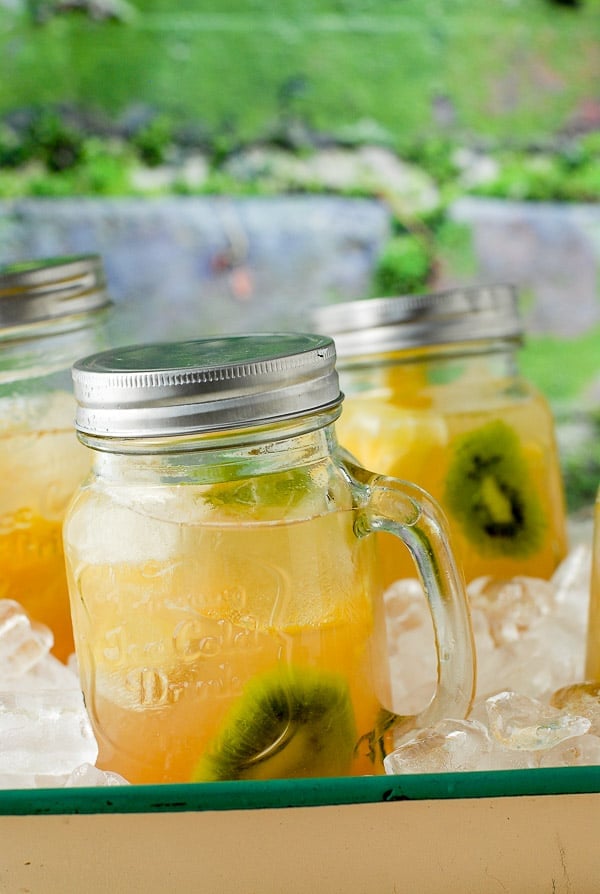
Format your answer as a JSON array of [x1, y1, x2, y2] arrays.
[[193, 667, 356, 782]]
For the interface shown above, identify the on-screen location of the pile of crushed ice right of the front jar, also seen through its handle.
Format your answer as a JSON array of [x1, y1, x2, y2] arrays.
[[385, 544, 600, 773]]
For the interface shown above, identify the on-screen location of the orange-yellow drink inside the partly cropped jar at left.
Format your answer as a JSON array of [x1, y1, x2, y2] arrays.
[[0, 393, 90, 661]]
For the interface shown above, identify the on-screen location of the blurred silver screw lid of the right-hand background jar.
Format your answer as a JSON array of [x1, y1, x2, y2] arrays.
[[313, 285, 523, 359]]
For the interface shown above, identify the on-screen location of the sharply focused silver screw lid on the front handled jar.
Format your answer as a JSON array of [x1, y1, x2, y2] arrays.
[[73, 333, 342, 438]]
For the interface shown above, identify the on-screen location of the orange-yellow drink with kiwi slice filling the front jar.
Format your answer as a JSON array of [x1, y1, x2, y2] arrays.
[[65, 486, 389, 782]]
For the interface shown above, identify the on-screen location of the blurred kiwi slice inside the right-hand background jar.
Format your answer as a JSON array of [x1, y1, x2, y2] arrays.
[[444, 420, 546, 558]]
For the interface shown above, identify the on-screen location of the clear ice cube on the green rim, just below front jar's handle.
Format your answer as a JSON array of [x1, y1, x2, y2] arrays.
[[384, 719, 492, 773]]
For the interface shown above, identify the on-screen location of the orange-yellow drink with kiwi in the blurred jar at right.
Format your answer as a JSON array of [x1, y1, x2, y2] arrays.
[[337, 362, 567, 584]]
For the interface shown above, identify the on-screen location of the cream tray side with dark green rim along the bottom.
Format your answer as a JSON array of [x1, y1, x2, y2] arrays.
[[0, 766, 600, 894]]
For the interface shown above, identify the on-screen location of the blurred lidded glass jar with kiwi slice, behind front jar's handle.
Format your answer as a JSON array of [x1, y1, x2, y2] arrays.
[[315, 285, 567, 584]]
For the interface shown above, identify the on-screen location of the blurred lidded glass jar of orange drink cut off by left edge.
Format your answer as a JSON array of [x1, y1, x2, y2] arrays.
[[0, 255, 110, 661]]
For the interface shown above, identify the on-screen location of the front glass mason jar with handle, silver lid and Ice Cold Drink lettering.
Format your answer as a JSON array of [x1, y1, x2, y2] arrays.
[[64, 334, 474, 782]]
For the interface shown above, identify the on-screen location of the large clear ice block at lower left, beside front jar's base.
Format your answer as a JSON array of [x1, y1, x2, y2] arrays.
[[0, 689, 98, 776]]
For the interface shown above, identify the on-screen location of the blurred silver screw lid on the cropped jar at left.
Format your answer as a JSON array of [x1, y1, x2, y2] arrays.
[[0, 255, 111, 329]]
